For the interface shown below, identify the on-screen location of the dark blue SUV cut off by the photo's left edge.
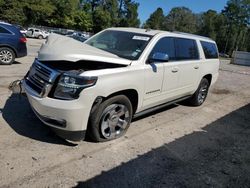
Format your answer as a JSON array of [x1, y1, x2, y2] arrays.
[[0, 22, 27, 65]]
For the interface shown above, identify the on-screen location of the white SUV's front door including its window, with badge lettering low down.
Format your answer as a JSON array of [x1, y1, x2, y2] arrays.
[[143, 37, 179, 108]]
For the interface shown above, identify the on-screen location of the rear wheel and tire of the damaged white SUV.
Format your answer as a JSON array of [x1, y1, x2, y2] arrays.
[[188, 78, 210, 106]]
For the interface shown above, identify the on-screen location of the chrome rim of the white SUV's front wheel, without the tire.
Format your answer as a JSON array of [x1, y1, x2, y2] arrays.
[[101, 104, 130, 139]]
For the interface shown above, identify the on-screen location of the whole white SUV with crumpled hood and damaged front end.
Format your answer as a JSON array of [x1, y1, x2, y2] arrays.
[[23, 28, 219, 141]]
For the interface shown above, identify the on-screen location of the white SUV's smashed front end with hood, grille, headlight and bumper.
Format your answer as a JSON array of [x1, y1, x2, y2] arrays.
[[19, 35, 134, 141]]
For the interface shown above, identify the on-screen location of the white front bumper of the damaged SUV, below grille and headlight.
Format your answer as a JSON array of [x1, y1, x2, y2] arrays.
[[22, 81, 93, 141]]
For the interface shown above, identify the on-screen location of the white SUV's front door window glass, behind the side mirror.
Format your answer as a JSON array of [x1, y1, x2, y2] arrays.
[[150, 37, 175, 61]]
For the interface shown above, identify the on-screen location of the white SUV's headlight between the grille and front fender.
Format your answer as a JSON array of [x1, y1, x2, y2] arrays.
[[54, 74, 97, 100]]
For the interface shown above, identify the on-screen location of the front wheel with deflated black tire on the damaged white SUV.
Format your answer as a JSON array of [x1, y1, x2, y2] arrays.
[[88, 95, 133, 142]]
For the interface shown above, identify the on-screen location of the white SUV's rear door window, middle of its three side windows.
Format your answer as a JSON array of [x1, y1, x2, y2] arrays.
[[175, 38, 199, 60]]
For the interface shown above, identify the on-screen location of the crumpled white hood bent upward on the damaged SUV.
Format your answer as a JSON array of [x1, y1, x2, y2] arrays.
[[38, 34, 131, 65]]
